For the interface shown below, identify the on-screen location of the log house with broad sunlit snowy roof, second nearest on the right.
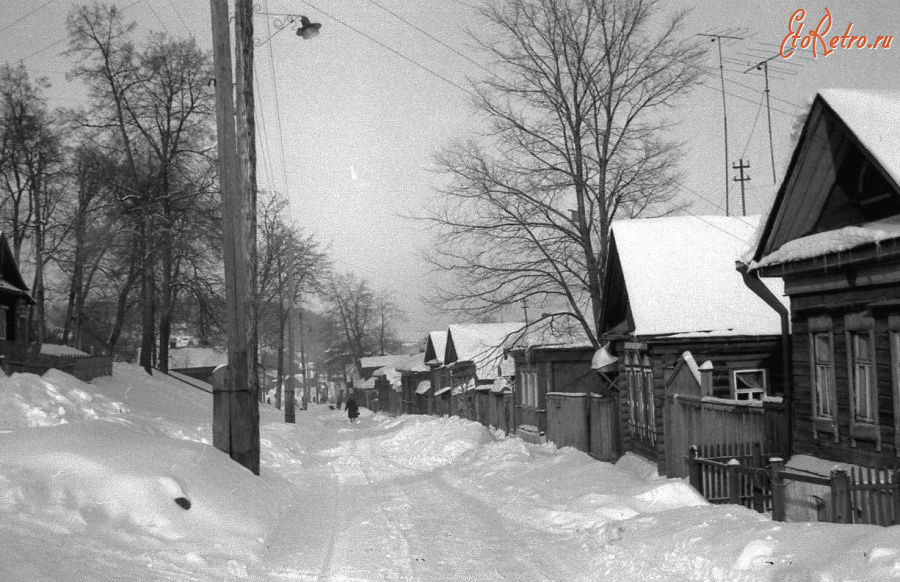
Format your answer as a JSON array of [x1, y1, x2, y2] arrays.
[[598, 216, 782, 473]]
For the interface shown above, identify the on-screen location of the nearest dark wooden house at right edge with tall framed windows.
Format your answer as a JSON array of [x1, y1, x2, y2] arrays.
[[744, 90, 900, 468]]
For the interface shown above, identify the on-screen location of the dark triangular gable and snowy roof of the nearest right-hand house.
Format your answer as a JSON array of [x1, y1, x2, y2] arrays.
[[751, 89, 900, 267]]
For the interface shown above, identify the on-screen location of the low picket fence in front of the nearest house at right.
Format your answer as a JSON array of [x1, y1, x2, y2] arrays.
[[685, 444, 900, 526]]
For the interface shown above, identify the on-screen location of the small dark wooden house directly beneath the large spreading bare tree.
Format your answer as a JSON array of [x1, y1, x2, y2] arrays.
[[509, 317, 599, 438]]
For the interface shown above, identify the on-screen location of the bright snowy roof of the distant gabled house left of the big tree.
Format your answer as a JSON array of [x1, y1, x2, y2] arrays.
[[444, 322, 525, 380]]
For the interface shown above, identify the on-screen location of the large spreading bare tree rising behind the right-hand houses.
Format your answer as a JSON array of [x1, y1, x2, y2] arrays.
[[425, 0, 702, 343]]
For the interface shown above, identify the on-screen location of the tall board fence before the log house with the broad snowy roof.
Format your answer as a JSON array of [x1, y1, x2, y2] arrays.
[[663, 394, 788, 477]]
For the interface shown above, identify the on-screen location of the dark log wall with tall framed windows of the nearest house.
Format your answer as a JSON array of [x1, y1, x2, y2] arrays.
[[785, 276, 900, 467]]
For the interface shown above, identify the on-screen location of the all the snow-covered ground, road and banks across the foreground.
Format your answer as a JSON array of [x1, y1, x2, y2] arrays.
[[0, 364, 900, 582]]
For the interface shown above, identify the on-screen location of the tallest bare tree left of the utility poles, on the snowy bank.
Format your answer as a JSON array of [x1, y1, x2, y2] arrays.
[[66, 4, 216, 371]]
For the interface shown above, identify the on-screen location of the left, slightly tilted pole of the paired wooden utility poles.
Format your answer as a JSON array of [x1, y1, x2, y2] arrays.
[[210, 0, 259, 475]]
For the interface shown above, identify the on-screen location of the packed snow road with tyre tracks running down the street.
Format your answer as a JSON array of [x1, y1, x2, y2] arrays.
[[263, 407, 589, 580]]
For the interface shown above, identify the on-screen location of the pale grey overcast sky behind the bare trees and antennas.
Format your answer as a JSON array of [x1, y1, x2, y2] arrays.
[[0, 0, 900, 336]]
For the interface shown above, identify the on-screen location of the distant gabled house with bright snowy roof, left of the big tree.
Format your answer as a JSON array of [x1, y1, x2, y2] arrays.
[[442, 323, 525, 420]]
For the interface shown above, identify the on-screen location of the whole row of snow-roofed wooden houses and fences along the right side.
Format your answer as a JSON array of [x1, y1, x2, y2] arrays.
[[356, 90, 900, 522]]
